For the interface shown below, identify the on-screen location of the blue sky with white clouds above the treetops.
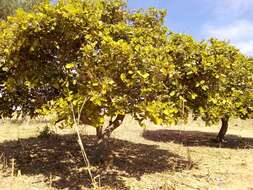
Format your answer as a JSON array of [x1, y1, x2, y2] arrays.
[[128, 0, 253, 55]]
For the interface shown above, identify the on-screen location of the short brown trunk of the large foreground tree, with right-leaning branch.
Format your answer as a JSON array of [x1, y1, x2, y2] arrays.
[[94, 115, 125, 168]]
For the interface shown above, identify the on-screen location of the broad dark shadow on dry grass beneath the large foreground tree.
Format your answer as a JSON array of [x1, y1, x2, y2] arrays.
[[0, 134, 189, 189]]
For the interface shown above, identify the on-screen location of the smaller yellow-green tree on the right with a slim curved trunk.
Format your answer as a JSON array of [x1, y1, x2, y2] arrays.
[[167, 34, 253, 142]]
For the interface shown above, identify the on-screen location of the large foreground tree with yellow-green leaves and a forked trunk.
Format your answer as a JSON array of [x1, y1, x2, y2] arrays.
[[0, 0, 180, 162]]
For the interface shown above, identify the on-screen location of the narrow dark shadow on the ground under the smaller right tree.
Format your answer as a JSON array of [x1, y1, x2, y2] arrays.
[[142, 129, 253, 149]]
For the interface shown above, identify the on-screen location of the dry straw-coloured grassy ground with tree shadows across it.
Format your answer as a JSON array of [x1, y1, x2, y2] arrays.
[[0, 114, 253, 190]]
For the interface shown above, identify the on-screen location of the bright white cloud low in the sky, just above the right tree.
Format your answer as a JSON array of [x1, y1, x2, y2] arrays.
[[202, 20, 253, 55]]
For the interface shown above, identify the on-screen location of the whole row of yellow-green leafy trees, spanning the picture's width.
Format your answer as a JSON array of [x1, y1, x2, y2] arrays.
[[0, 0, 253, 149]]
